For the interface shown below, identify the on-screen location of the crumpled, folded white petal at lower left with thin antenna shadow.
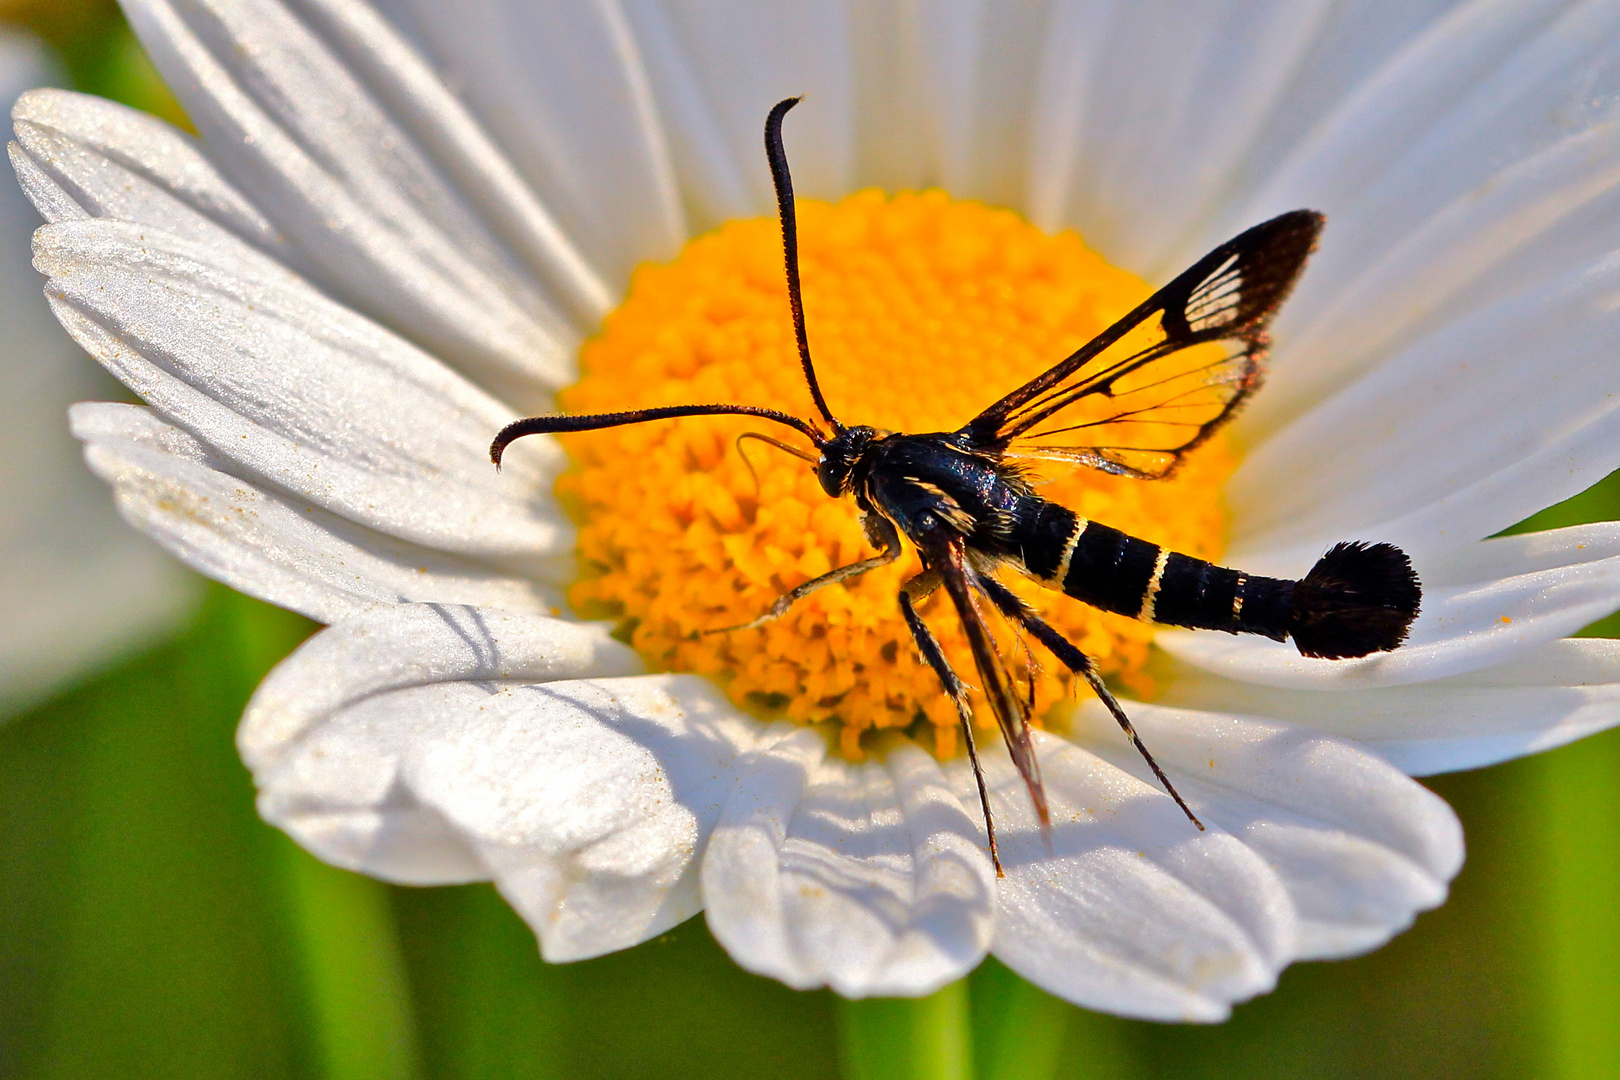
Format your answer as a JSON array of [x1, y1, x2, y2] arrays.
[[238, 604, 760, 960]]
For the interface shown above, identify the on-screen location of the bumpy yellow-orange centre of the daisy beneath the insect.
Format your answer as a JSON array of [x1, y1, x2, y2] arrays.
[[557, 191, 1233, 758]]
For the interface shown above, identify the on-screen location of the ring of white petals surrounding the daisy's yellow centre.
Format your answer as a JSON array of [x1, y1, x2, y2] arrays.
[[13, 0, 1620, 1020]]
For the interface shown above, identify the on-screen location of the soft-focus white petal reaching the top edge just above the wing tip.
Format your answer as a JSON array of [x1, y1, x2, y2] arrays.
[[1022, 0, 1332, 279]]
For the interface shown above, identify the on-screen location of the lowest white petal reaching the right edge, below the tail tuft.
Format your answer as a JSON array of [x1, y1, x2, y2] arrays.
[[1162, 638, 1620, 776]]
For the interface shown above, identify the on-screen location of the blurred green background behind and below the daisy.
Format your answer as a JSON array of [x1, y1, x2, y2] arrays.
[[0, 0, 1620, 1080]]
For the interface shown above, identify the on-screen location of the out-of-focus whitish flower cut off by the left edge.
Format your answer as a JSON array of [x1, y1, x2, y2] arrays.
[[0, 29, 194, 716]]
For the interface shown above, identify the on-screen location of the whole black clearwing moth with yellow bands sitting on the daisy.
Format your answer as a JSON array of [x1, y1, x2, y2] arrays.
[[489, 99, 1421, 874]]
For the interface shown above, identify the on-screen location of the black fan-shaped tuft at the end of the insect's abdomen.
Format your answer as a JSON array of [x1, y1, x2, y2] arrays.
[[1288, 541, 1422, 661]]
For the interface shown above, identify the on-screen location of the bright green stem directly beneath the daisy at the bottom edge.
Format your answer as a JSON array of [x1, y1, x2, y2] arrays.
[[838, 980, 974, 1080]]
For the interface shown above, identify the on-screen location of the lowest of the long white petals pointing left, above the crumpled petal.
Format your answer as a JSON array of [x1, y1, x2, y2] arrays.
[[73, 403, 572, 623]]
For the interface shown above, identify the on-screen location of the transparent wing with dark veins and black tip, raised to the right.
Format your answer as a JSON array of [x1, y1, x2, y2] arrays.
[[959, 210, 1324, 479]]
